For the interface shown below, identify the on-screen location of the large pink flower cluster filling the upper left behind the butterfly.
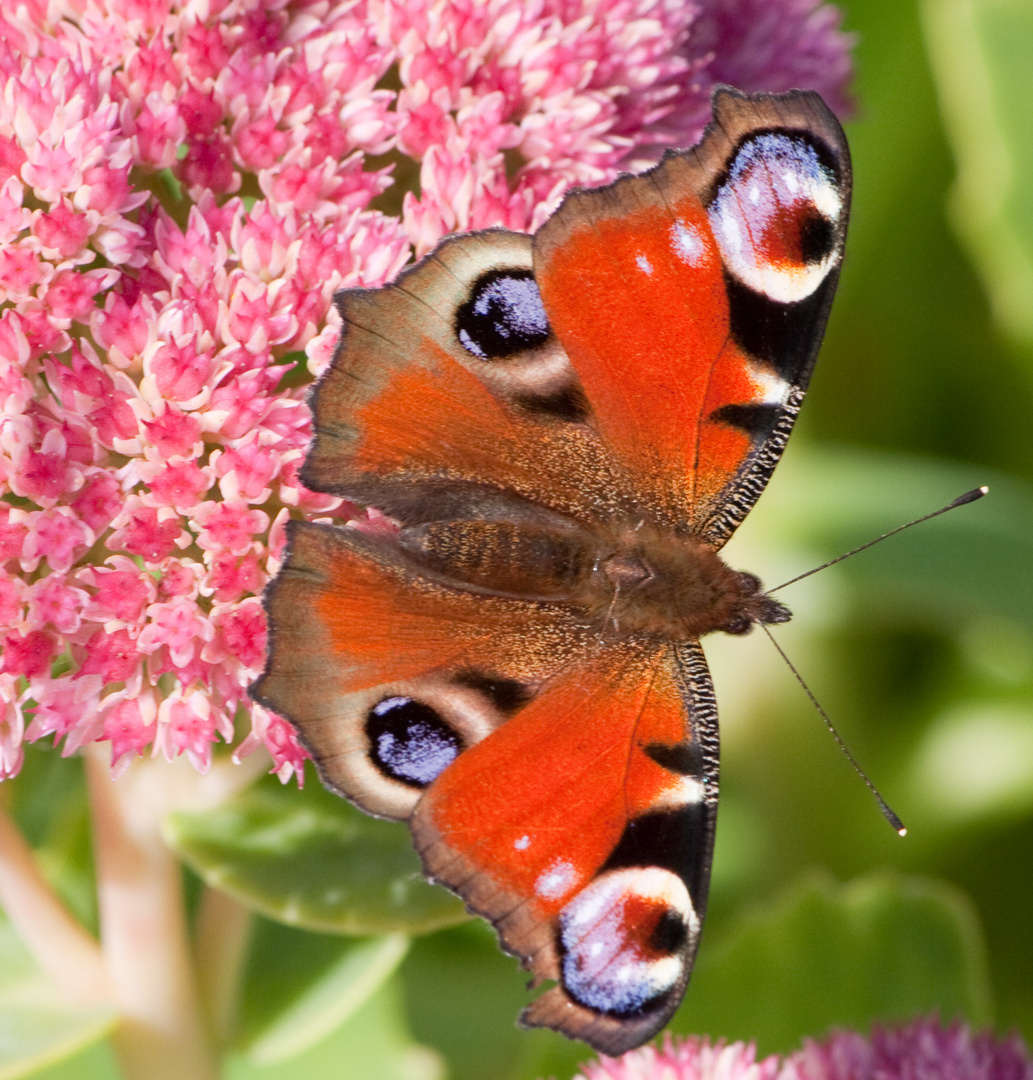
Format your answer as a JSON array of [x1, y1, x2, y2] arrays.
[[0, 0, 849, 780]]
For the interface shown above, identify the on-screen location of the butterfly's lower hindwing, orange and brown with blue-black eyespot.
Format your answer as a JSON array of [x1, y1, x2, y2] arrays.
[[251, 522, 598, 820]]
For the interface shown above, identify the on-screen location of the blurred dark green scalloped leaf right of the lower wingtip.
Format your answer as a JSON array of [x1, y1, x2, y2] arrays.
[[671, 873, 991, 1053]]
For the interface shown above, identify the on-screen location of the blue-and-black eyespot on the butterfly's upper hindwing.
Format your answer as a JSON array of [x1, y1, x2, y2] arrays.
[[456, 270, 551, 360]]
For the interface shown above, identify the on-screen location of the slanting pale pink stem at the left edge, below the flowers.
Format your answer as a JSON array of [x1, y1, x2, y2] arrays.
[[0, 807, 113, 1005]]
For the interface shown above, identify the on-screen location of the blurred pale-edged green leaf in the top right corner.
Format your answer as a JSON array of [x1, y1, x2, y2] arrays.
[[923, 0, 1033, 343]]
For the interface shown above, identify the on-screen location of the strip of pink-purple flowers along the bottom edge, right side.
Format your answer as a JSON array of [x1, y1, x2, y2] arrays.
[[575, 1017, 1033, 1080]]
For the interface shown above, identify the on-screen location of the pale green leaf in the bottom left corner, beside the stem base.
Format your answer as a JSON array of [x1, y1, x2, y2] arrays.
[[0, 919, 118, 1080]]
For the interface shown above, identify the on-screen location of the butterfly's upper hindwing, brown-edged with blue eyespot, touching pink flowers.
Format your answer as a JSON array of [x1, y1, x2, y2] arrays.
[[301, 229, 629, 524]]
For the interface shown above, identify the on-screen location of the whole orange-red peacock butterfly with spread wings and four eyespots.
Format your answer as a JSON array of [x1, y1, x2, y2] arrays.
[[253, 87, 850, 1055]]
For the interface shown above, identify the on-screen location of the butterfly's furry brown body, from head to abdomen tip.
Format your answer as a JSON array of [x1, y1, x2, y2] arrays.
[[399, 512, 790, 640]]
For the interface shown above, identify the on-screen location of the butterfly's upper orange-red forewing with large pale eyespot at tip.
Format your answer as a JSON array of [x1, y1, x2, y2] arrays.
[[534, 90, 850, 546]]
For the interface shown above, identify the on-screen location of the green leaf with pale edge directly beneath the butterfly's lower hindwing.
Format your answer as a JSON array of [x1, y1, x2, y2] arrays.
[[165, 778, 466, 935]]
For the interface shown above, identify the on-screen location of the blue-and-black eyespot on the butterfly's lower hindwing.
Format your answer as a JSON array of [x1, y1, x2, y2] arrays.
[[366, 698, 462, 787]]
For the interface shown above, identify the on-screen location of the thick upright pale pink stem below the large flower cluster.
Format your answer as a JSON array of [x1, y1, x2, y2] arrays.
[[86, 754, 218, 1080]]
